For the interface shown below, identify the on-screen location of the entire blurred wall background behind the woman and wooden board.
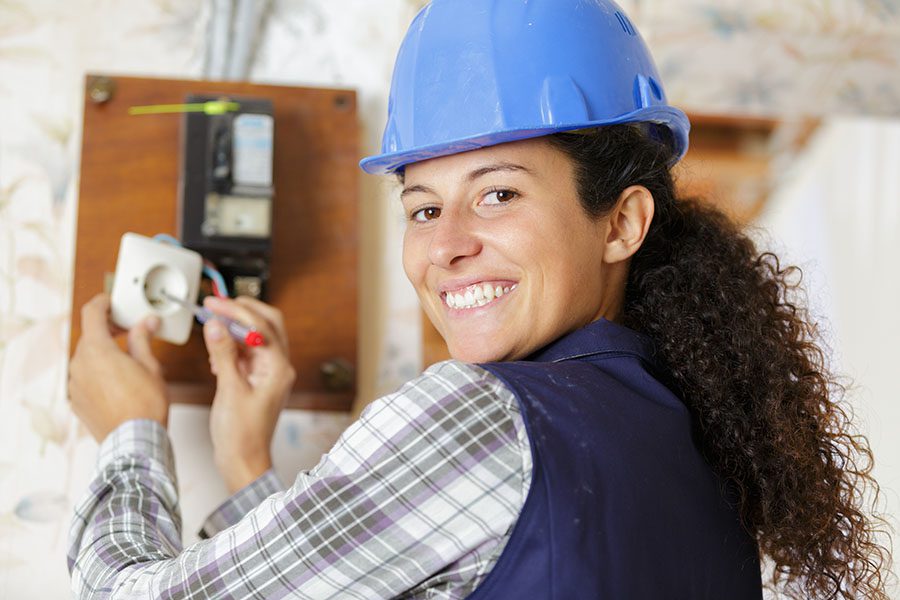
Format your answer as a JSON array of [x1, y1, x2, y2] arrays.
[[0, 0, 900, 600]]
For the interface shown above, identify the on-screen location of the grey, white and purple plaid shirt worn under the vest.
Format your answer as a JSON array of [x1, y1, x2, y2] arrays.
[[69, 361, 531, 600]]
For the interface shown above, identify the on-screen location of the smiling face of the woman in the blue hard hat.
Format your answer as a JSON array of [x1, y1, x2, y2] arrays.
[[401, 139, 612, 362]]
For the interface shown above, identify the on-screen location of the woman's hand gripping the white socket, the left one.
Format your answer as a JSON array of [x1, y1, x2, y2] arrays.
[[69, 294, 169, 442]]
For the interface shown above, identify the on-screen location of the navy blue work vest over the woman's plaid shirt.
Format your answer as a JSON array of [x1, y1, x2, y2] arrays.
[[469, 319, 762, 600]]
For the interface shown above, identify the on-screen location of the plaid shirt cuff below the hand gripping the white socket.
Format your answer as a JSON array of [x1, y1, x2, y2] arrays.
[[97, 419, 175, 482]]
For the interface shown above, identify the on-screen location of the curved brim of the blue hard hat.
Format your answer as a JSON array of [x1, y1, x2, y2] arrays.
[[359, 106, 690, 175]]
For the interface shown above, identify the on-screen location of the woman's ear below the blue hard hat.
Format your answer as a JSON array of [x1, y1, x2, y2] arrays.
[[603, 185, 654, 263]]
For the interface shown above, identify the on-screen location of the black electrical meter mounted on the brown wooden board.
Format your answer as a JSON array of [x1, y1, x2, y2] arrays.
[[178, 94, 275, 299]]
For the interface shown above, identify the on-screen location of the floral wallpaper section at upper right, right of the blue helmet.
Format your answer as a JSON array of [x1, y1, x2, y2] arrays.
[[631, 0, 900, 116]]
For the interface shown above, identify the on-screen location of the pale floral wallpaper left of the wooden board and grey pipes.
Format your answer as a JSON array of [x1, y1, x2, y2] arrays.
[[0, 0, 203, 598]]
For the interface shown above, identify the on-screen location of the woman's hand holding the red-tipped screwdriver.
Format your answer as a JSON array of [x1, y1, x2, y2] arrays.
[[203, 296, 296, 492]]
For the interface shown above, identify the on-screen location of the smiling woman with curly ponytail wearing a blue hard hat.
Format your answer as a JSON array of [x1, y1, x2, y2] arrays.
[[70, 0, 889, 599]]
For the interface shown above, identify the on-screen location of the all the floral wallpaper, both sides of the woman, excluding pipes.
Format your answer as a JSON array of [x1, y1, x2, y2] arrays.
[[0, 0, 900, 600]]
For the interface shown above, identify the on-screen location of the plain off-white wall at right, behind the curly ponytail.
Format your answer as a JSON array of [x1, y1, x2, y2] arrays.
[[757, 117, 900, 598]]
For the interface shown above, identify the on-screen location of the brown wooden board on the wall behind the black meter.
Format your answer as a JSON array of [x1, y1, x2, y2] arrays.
[[72, 75, 359, 410]]
